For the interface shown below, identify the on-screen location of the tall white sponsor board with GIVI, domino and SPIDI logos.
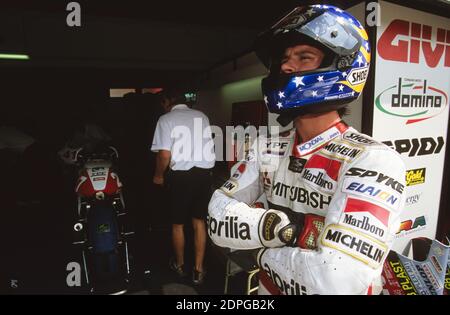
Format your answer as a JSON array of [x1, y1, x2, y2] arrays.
[[372, 0, 450, 252]]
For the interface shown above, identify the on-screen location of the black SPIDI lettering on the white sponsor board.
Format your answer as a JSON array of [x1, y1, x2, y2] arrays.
[[383, 137, 444, 157]]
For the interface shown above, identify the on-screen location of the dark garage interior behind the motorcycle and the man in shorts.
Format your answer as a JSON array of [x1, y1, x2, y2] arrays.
[[0, 0, 446, 294]]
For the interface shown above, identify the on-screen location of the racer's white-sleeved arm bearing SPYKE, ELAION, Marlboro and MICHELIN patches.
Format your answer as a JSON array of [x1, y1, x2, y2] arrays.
[[258, 148, 405, 294]]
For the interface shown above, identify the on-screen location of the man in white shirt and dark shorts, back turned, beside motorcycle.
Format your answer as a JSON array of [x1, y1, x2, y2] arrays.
[[152, 88, 215, 284]]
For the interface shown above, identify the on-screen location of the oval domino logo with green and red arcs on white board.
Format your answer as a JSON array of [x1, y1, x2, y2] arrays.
[[375, 78, 448, 125]]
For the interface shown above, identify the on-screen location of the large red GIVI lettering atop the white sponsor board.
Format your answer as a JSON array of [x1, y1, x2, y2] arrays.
[[377, 20, 450, 68]]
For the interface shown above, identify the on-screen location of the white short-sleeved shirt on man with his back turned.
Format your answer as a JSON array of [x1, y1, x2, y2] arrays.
[[151, 104, 216, 171]]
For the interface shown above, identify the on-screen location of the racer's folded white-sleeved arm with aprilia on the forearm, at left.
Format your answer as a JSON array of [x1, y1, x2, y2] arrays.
[[207, 138, 290, 249]]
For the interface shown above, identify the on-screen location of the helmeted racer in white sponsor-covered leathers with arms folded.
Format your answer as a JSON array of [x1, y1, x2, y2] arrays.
[[208, 5, 405, 295]]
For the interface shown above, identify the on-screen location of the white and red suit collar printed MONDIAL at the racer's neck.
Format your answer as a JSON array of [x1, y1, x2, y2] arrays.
[[292, 120, 349, 157]]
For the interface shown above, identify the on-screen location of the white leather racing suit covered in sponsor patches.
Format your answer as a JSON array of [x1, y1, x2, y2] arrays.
[[208, 122, 405, 294]]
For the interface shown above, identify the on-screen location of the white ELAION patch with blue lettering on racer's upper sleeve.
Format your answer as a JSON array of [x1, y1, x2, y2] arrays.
[[342, 178, 401, 210]]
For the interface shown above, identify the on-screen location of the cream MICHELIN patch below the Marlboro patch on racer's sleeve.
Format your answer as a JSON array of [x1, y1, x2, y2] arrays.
[[321, 224, 388, 269]]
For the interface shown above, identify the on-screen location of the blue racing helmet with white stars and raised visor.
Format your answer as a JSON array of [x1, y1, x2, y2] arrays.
[[255, 5, 370, 125]]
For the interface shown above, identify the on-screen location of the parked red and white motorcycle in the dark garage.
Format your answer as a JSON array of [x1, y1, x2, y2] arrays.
[[67, 146, 134, 294]]
